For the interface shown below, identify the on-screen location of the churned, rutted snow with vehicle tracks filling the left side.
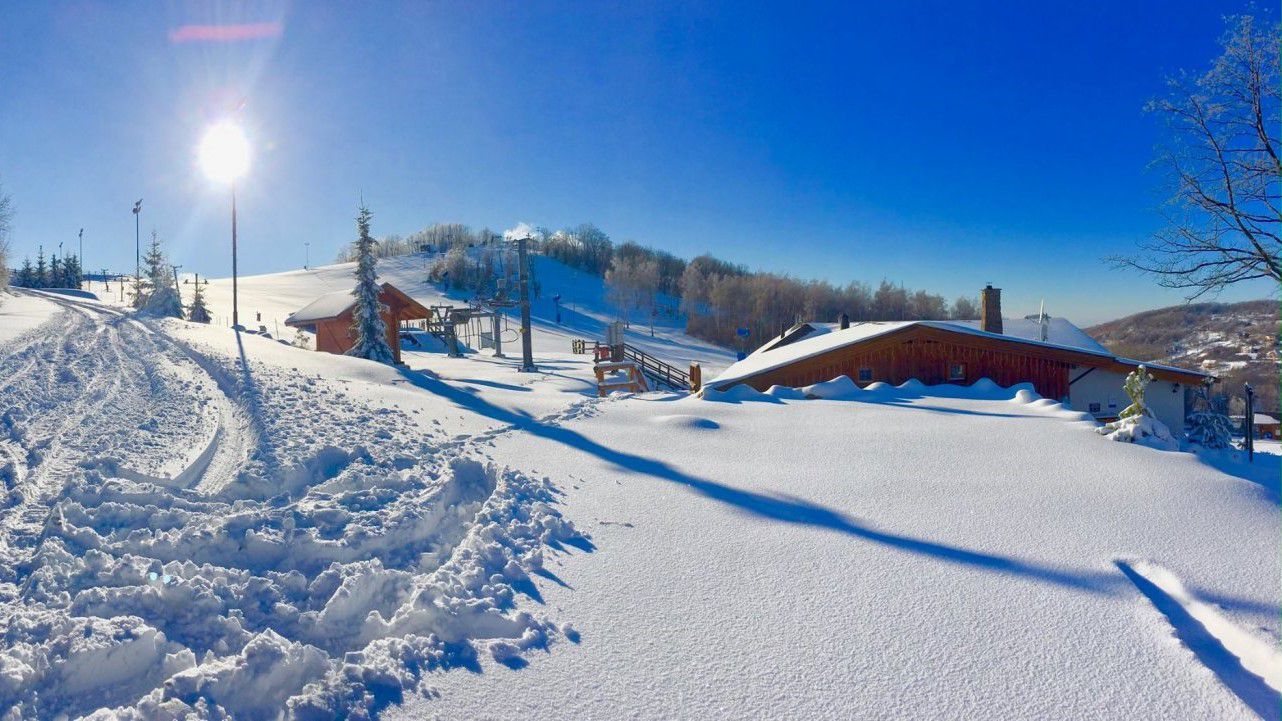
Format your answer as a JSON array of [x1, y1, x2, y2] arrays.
[[0, 294, 595, 720]]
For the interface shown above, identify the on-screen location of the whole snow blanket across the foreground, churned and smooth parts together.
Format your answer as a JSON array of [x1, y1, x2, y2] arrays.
[[0, 258, 1282, 718]]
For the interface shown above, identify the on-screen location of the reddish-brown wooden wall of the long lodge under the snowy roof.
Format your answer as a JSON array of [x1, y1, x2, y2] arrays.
[[745, 327, 1123, 399]]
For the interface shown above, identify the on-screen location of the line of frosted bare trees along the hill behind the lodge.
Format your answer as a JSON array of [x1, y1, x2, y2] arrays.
[[361, 223, 978, 348]]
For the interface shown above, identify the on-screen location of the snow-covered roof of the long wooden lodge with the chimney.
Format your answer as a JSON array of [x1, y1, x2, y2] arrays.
[[706, 318, 1208, 387]]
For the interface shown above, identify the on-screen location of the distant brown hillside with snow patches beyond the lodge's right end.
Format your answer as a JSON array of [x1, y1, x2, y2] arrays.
[[1087, 300, 1279, 412]]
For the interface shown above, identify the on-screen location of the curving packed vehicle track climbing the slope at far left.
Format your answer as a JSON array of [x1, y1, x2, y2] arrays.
[[0, 288, 253, 581]]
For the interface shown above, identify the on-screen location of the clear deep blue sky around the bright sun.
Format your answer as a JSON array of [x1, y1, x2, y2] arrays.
[[0, 1, 1270, 323]]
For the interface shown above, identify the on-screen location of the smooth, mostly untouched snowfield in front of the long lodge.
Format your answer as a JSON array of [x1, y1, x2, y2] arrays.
[[390, 384, 1282, 720]]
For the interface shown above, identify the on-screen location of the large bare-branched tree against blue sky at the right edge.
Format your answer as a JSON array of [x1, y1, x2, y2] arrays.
[[1114, 15, 1282, 300]]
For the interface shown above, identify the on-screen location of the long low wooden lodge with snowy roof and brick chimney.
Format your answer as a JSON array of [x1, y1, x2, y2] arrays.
[[706, 286, 1211, 428]]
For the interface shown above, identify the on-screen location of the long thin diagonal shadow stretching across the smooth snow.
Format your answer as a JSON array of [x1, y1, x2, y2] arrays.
[[399, 368, 1124, 594]]
